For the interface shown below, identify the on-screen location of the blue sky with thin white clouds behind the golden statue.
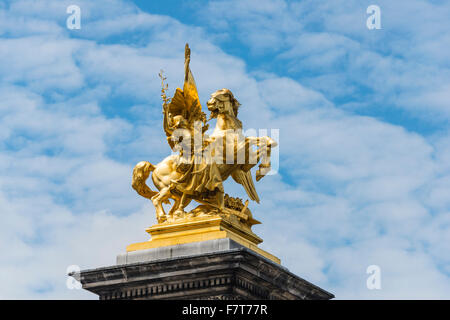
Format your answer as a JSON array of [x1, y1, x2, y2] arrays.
[[0, 0, 450, 299]]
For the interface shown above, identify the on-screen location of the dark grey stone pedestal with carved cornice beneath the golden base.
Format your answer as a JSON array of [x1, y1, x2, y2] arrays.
[[74, 237, 334, 300]]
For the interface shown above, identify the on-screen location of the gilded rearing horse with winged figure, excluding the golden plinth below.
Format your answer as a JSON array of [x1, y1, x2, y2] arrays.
[[132, 44, 277, 223]]
